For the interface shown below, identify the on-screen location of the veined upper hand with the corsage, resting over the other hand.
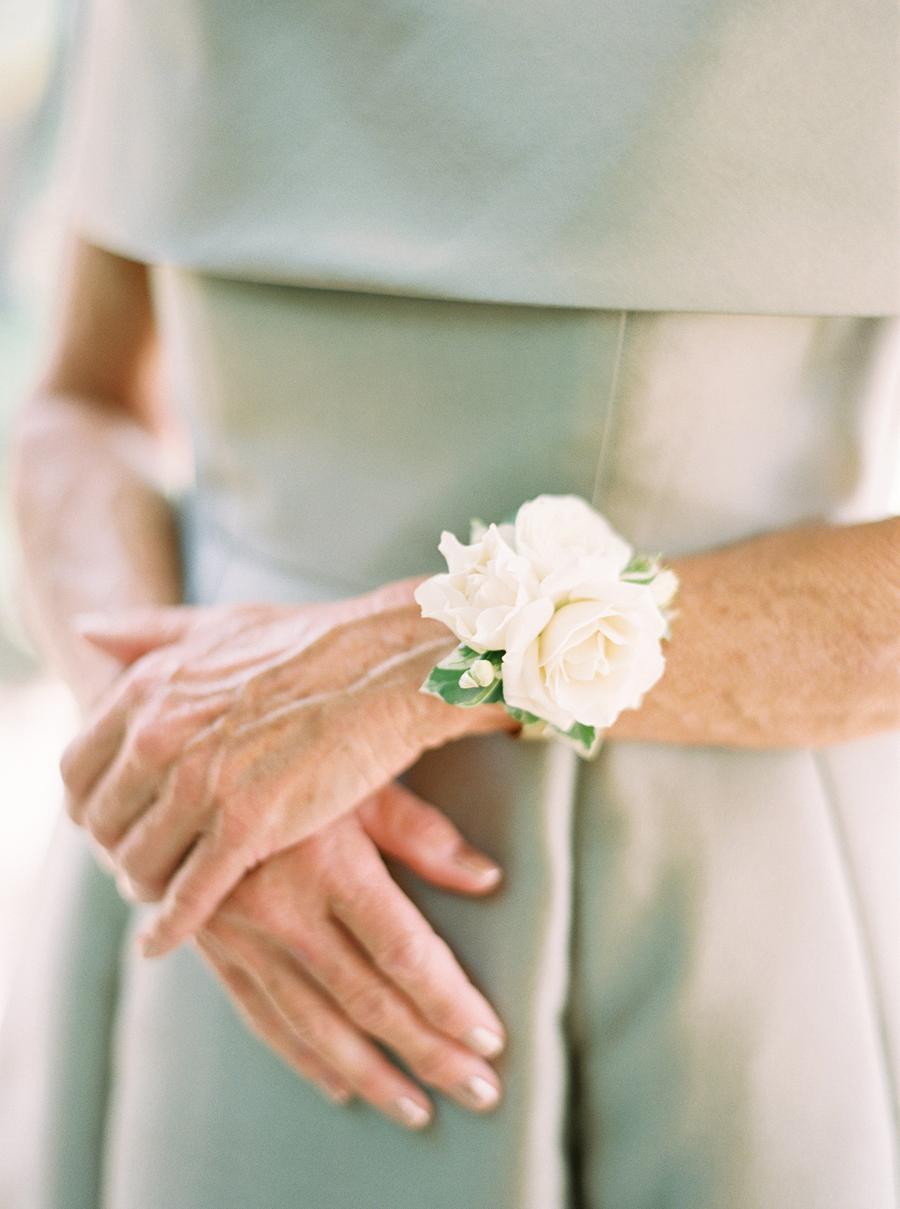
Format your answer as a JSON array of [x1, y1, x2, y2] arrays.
[[60, 580, 515, 955]]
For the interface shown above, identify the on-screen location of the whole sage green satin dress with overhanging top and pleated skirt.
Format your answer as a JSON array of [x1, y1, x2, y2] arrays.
[[0, 0, 900, 1209]]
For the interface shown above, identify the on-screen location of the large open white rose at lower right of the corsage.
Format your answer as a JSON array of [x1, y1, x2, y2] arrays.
[[502, 582, 667, 730]]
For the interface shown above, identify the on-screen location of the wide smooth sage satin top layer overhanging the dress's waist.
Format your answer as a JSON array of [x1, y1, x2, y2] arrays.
[[63, 0, 900, 316]]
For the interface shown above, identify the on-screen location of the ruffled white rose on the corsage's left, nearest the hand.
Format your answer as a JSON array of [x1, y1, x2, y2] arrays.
[[415, 525, 544, 652]]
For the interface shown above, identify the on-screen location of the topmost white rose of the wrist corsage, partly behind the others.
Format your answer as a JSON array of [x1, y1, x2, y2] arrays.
[[515, 496, 634, 601]]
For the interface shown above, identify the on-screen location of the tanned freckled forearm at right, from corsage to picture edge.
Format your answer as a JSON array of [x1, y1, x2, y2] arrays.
[[607, 517, 900, 747]]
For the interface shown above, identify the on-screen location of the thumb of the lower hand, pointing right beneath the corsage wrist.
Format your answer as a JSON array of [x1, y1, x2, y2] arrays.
[[358, 781, 503, 895]]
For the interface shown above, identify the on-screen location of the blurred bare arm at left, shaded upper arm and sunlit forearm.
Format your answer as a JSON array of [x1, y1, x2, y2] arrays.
[[13, 239, 181, 706]]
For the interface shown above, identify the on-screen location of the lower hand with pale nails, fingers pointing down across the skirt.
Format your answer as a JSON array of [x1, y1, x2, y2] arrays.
[[196, 783, 503, 1129]]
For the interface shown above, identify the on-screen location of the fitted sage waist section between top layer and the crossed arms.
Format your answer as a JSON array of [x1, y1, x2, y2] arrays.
[[152, 266, 900, 598]]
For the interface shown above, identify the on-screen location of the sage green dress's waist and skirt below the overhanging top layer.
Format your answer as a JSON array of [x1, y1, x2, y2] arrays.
[[0, 274, 900, 1209]]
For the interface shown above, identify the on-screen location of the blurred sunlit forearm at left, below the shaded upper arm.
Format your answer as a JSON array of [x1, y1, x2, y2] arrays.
[[13, 389, 181, 705]]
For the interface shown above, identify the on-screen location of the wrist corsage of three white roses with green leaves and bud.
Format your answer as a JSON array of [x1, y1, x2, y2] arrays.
[[415, 496, 677, 757]]
